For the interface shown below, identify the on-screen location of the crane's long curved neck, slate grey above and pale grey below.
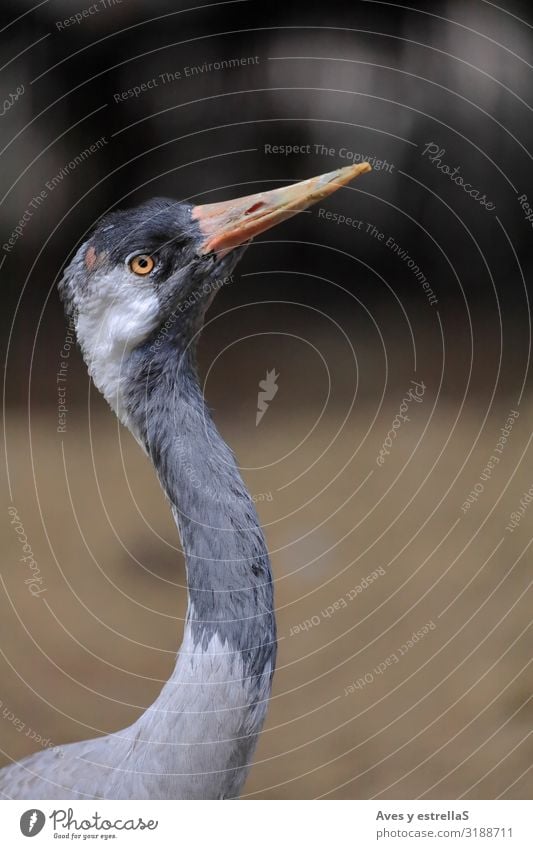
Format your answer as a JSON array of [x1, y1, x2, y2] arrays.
[[123, 336, 276, 798]]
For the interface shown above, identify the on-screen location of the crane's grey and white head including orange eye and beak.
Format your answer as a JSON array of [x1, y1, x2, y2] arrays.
[[59, 162, 371, 419]]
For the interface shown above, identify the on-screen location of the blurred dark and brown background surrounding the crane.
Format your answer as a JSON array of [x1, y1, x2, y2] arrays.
[[0, 0, 533, 799]]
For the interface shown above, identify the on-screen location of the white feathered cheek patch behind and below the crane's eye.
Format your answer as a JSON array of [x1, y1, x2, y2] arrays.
[[76, 268, 160, 426]]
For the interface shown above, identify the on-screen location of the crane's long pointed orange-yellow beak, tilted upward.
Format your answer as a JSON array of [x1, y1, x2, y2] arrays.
[[192, 162, 372, 256]]
